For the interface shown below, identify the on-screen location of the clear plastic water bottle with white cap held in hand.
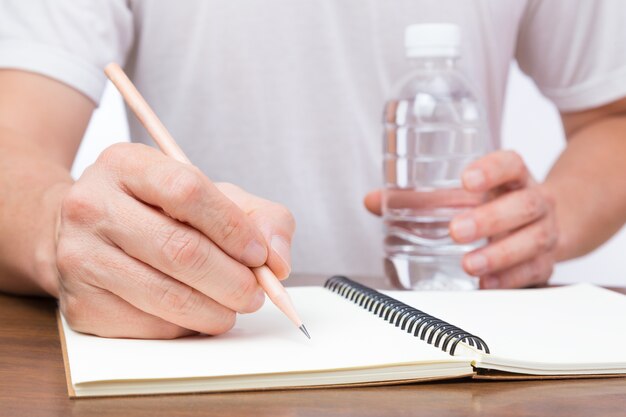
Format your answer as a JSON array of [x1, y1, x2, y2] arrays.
[[383, 24, 490, 289]]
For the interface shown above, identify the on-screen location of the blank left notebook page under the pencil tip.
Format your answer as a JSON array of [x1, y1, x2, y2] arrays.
[[63, 287, 467, 384]]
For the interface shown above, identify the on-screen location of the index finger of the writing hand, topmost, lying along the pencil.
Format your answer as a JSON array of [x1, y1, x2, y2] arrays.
[[98, 144, 267, 266]]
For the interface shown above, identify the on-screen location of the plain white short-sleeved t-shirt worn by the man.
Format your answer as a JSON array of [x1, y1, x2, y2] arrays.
[[0, 0, 626, 275]]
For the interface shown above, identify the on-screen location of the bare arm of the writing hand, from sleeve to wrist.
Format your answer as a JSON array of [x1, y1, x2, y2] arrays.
[[0, 69, 94, 296]]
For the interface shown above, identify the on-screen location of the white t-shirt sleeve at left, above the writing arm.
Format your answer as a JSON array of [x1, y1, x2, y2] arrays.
[[0, 0, 133, 103]]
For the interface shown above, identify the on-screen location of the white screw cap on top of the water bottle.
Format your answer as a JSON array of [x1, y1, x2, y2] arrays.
[[404, 23, 461, 58]]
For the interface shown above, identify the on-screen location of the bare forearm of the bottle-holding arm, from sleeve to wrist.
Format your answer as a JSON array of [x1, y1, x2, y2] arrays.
[[543, 115, 626, 260]]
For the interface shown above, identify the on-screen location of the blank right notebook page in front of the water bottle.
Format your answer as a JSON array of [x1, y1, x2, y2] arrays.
[[388, 284, 626, 370]]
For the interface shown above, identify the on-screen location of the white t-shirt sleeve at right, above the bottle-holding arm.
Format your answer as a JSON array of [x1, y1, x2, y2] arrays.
[[516, 0, 626, 112]]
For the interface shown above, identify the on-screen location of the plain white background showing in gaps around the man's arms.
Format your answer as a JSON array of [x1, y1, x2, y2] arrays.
[[72, 66, 626, 285]]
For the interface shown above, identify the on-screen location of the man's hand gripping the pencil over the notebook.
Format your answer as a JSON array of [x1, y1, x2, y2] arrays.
[[56, 144, 295, 338]]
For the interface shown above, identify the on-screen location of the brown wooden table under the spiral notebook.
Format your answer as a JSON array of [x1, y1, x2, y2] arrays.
[[0, 277, 626, 417]]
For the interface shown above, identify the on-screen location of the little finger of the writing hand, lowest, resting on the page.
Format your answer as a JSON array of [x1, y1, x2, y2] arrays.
[[59, 283, 196, 339]]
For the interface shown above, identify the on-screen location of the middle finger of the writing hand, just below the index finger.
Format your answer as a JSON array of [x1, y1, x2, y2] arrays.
[[100, 195, 265, 313]]
